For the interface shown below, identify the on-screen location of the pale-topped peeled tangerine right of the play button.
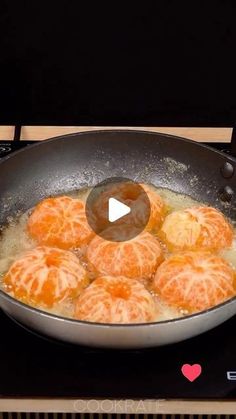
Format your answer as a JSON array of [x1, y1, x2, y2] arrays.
[[159, 207, 233, 251]]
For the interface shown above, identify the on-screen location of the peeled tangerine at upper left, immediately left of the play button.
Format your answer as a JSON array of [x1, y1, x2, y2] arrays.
[[28, 196, 93, 249]]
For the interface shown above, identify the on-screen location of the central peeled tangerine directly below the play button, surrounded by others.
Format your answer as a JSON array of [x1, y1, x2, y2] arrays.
[[87, 226, 163, 279]]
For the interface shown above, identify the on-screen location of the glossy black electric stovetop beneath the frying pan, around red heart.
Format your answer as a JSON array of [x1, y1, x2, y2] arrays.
[[0, 142, 236, 400]]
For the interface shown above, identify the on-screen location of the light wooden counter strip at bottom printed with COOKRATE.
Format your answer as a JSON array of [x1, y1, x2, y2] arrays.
[[0, 399, 236, 419]]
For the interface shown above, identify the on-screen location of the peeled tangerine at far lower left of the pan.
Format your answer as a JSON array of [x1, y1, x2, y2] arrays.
[[4, 247, 88, 307]]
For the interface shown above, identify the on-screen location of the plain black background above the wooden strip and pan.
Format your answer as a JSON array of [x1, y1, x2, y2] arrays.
[[0, 0, 236, 126]]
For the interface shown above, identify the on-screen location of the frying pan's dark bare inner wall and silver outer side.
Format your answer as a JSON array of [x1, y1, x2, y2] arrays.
[[0, 130, 236, 348]]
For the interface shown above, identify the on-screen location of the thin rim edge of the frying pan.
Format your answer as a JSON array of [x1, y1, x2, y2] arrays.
[[0, 129, 236, 329]]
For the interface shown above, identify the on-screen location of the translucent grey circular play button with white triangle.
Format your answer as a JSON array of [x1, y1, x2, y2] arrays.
[[86, 178, 151, 242]]
